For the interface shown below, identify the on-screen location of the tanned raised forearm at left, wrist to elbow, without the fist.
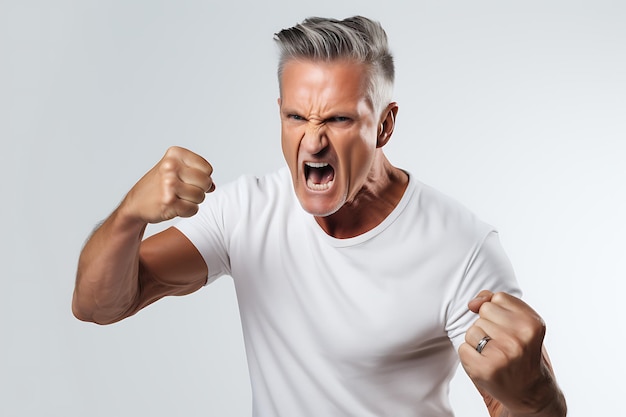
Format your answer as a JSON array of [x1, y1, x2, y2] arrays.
[[72, 206, 146, 324]]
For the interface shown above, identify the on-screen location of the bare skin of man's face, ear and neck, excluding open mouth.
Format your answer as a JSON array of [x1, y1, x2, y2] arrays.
[[278, 61, 408, 238]]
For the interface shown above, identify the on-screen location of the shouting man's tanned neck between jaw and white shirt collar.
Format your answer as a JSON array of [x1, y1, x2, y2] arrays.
[[315, 151, 409, 239]]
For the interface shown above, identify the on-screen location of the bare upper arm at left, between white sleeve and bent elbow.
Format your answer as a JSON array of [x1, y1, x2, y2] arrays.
[[137, 227, 208, 310]]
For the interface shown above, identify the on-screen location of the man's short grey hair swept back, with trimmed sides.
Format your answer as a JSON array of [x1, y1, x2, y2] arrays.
[[274, 16, 395, 113]]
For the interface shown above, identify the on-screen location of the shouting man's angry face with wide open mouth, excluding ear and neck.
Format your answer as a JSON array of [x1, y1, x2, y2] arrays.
[[279, 60, 379, 217]]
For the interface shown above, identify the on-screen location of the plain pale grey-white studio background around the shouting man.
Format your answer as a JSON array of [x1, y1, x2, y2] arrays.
[[0, 0, 626, 417]]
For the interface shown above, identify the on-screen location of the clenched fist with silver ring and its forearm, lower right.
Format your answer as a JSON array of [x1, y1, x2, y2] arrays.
[[459, 291, 567, 417]]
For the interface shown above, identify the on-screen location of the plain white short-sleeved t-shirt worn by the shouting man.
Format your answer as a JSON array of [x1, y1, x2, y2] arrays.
[[177, 168, 520, 417]]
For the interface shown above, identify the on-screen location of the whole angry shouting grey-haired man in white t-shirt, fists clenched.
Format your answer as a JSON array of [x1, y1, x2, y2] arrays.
[[73, 17, 566, 416]]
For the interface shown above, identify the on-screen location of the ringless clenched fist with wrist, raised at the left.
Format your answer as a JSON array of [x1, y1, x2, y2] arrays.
[[121, 146, 215, 223]]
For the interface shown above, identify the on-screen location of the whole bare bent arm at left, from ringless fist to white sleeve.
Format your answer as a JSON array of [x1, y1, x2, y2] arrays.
[[72, 147, 215, 324]]
